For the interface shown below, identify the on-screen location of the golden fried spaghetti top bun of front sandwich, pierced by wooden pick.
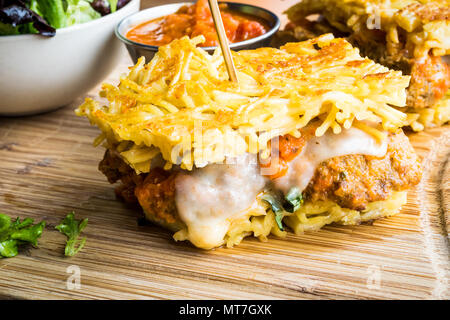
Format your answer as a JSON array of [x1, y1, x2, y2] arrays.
[[77, 34, 409, 173]]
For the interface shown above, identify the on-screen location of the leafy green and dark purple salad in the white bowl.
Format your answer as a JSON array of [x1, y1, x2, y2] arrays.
[[0, 0, 130, 36]]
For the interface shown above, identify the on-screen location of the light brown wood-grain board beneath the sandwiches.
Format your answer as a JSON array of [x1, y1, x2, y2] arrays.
[[0, 1, 450, 299]]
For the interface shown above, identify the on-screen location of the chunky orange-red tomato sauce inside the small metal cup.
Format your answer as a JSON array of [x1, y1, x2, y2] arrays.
[[126, 0, 269, 47]]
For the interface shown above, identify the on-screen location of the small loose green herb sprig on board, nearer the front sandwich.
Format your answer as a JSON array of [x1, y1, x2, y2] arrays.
[[55, 211, 88, 257]]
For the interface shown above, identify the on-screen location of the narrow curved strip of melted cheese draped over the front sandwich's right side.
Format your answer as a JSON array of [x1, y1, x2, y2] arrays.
[[273, 127, 387, 193]]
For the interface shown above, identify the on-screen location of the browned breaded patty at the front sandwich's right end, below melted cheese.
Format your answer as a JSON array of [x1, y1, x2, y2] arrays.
[[304, 131, 422, 210]]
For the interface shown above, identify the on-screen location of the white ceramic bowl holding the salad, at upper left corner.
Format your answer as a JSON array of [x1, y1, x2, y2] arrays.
[[0, 0, 140, 115]]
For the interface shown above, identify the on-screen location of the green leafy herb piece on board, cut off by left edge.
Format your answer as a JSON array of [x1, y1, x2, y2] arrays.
[[0, 213, 45, 258]]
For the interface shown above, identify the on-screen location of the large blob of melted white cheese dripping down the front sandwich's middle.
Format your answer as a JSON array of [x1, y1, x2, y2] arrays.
[[175, 154, 266, 249]]
